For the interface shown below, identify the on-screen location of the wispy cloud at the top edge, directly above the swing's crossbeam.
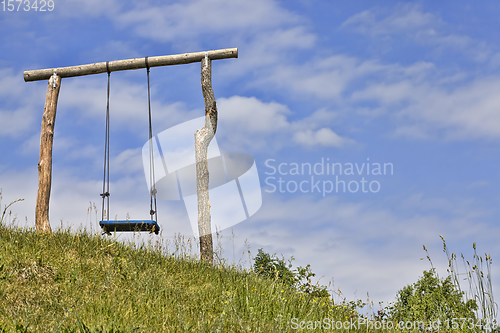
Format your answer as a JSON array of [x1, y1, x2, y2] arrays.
[[115, 0, 299, 42]]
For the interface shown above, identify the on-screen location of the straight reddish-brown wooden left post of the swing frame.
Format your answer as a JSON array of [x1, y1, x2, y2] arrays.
[[35, 71, 61, 232]]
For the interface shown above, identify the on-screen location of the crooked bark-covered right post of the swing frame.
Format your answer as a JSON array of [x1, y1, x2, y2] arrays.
[[194, 54, 217, 264]]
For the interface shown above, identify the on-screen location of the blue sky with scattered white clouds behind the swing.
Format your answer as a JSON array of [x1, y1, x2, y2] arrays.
[[0, 0, 500, 312]]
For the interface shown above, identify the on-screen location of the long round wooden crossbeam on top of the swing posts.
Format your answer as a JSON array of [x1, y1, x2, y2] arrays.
[[24, 48, 238, 82]]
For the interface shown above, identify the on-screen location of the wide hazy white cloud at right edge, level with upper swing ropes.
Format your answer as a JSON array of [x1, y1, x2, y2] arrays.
[[352, 77, 500, 140]]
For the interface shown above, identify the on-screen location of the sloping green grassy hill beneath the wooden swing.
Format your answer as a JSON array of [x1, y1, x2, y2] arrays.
[[0, 224, 364, 332]]
